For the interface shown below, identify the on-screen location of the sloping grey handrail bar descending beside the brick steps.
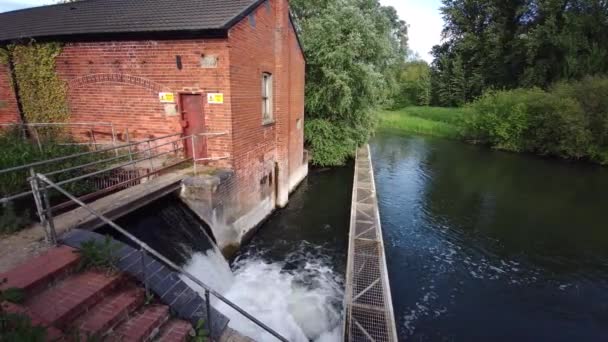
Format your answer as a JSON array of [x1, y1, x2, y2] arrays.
[[34, 173, 289, 342]]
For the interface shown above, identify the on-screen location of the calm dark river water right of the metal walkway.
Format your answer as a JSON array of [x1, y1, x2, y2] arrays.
[[371, 134, 608, 341]]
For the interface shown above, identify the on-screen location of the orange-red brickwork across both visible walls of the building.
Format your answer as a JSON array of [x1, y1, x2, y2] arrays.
[[0, 0, 305, 222]]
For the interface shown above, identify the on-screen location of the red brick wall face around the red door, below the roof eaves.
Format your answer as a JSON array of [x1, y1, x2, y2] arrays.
[[57, 39, 232, 165]]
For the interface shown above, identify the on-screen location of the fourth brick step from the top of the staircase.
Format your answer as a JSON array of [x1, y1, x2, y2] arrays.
[[106, 305, 169, 342]]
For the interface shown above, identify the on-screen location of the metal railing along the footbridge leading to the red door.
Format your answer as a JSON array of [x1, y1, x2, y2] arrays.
[[0, 132, 229, 235]]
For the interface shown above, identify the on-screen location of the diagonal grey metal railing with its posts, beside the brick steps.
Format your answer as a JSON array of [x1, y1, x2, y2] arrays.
[[30, 174, 288, 342]]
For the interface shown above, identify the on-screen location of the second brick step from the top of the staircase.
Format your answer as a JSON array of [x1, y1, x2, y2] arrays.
[[25, 271, 124, 328]]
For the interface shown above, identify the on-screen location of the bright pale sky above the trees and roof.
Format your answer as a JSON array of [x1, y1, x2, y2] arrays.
[[0, 0, 443, 63]]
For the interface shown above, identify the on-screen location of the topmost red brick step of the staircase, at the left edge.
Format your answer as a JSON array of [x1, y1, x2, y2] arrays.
[[0, 246, 80, 297]]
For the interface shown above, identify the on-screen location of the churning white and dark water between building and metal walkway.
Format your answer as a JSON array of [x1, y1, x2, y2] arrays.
[[104, 165, 353, 342]]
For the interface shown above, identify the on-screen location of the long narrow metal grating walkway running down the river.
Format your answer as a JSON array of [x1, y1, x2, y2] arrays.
[[344, 146, 397, 342]]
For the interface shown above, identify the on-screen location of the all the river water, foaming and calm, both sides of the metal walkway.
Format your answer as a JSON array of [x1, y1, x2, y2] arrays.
[[102, 130, 608, 342]]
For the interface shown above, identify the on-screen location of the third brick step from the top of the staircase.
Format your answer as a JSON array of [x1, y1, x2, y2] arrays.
[[71, 284, 145, 338]]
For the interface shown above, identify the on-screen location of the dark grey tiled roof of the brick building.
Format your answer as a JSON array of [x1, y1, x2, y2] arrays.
[[0, 0, 264, 42]]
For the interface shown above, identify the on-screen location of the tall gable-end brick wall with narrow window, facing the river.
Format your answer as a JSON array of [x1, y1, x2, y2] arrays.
[[229, 0, 304, 211]]
